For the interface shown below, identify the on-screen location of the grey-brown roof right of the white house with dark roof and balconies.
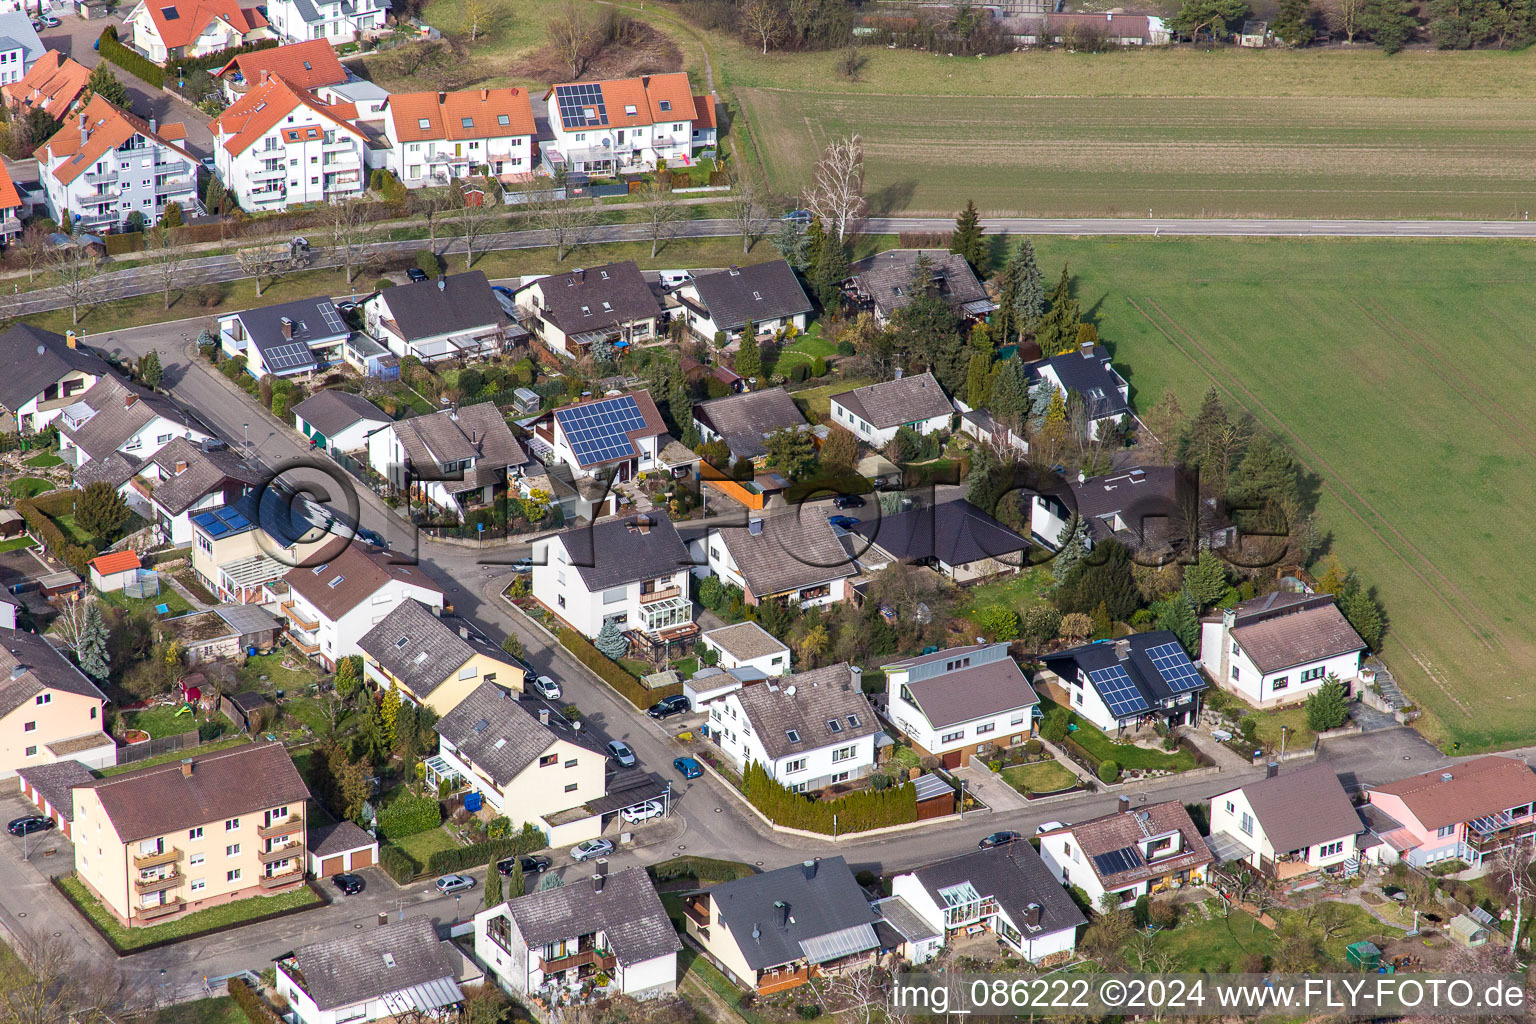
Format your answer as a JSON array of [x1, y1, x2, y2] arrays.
[[710, 505, 857, 599]]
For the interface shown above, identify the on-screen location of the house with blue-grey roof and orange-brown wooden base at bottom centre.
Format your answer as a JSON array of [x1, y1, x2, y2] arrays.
[[684, 857, 880, 995]]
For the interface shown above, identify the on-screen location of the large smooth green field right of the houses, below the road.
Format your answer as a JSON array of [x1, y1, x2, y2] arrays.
[[1035, 238, 1536, 752]]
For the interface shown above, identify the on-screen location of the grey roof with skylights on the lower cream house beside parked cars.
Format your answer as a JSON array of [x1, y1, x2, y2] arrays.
[[435, 683, 596, 786]]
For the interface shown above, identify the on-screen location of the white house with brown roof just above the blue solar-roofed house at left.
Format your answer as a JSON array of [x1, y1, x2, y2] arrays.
[[120, 438, 270, 547]]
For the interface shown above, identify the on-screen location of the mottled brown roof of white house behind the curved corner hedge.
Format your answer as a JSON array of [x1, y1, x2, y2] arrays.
[[734, 663, 880, 758]]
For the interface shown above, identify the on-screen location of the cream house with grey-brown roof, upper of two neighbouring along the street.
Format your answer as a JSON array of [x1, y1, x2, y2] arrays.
[[358, 599, 527, 715]]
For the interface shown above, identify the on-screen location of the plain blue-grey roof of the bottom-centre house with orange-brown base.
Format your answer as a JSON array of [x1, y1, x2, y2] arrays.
[[708, 857, 879, 970]]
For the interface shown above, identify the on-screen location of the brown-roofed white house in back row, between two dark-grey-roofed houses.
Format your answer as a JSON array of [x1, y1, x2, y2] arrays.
[[513, 259, 662, 359]]
